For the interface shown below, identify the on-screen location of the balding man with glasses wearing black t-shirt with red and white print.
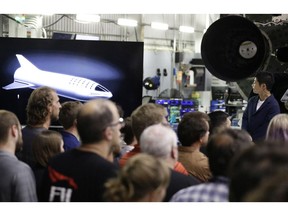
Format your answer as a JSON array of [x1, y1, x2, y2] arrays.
[[40, 99, 123, 202]]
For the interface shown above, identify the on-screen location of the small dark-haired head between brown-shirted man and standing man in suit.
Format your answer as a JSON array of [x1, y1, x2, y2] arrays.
[[208, 110, 231, 135]]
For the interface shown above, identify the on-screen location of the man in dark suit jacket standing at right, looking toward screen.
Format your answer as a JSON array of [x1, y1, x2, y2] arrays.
[[242, 72, 280, 142]]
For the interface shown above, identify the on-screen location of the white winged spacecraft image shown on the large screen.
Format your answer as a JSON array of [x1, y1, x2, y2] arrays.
[[2, 54, 112, 101]]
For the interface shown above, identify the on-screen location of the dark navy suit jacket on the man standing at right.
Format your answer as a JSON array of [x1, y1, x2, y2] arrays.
[[242, 95, 280, 141]]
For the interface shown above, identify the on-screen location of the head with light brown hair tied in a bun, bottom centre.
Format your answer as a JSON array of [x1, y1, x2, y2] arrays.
[[105, 153, 170, 202]]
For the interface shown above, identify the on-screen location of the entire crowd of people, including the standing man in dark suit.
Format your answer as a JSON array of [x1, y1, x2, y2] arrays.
[[0, 72, 288, 202]]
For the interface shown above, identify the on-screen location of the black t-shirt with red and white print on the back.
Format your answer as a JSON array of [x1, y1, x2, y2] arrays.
[[40, 149, 118, 202]]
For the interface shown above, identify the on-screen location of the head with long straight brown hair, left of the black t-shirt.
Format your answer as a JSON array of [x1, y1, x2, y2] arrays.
[[32, 130, 64, 167]]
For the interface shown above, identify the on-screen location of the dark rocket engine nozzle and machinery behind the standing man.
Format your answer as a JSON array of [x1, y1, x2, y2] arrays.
[[201, 14, 288, 112]]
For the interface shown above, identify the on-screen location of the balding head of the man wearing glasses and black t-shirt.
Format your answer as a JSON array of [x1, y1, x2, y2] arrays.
[[77, 98, 123, 146]]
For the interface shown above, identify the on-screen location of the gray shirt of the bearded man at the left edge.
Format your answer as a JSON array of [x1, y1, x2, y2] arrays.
[[0, 151, 37, 202]]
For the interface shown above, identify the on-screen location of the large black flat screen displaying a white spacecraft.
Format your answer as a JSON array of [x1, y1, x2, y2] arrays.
[[0, 38, 143, 124]]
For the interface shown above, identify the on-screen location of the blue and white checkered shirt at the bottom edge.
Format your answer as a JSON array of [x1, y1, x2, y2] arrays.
[[170, 176, 229, 202]]
